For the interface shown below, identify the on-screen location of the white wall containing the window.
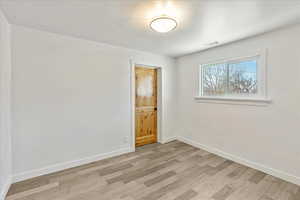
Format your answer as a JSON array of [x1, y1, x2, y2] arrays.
[[177, 25, 300, 184]]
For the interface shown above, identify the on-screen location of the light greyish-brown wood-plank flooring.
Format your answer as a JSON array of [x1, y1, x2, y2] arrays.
[[6, 141, 300, 200]]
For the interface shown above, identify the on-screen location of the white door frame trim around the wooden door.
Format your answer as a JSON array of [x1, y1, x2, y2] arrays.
[[130, 60, 162, 151]]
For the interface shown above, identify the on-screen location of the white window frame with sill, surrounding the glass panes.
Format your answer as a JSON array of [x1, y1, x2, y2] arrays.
[[195, 50, 271, 105]]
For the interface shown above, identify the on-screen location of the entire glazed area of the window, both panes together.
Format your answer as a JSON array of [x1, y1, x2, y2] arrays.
[[201, 58, 258, 96]]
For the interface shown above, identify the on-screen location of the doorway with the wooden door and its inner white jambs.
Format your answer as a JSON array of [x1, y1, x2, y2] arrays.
[[131, 64, 161, 150]]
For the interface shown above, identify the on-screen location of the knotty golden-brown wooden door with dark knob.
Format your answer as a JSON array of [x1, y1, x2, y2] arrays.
[[135, 67, 157, 146]]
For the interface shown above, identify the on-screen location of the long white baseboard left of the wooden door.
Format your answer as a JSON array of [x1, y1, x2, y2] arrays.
[[12, 147, 133, 183]]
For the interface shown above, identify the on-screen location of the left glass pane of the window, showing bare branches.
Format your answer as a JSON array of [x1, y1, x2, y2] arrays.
[[202, 63, 227, 96]]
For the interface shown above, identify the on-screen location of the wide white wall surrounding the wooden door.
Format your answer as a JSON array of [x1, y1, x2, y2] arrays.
[[12, 25, 176, 181]]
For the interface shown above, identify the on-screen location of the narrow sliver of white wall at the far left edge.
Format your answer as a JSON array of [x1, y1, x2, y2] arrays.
[[0, 10, 11, 199]]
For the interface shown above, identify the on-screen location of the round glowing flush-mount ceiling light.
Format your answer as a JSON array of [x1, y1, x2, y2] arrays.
[[150, 16, 177, 33]]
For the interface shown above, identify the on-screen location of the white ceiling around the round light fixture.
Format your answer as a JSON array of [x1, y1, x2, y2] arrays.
[[0, 0, 300, 57]]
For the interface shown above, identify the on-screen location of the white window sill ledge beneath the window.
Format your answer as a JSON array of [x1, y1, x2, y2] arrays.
[[195, 96, 272, 106]]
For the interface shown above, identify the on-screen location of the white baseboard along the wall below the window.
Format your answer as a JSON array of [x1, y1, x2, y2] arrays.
[[177, 136, 300, 185]]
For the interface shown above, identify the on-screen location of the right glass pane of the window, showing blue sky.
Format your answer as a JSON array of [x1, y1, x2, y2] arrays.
[[227, 60, 257, 95]]
